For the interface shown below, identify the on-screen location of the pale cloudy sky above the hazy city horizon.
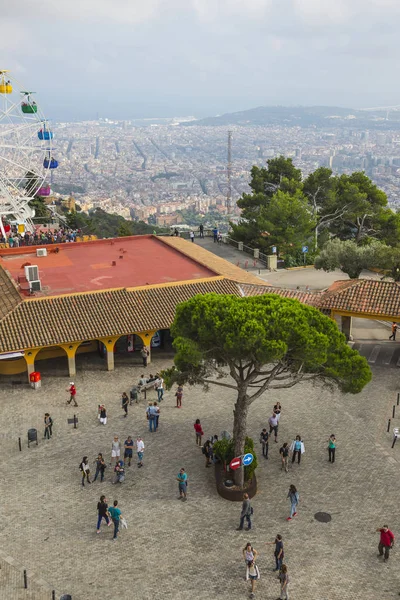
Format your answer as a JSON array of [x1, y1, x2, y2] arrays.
[[0, 0, 400, 119]]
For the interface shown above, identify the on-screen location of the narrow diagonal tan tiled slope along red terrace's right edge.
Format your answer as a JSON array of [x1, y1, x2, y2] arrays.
[[157, 236, 267, 286]]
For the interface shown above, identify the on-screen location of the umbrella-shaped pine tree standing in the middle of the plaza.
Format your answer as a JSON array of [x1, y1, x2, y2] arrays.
[[164, 294, 371, 485]]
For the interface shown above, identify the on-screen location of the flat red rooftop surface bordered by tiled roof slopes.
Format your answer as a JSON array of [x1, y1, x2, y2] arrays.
[[0, 235, 220, 296]]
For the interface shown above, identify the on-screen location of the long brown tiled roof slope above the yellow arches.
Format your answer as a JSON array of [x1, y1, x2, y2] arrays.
[[0, 277, 239, 352]]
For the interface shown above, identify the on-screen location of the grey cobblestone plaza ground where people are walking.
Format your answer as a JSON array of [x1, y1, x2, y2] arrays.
[[0, 359, 400, 600]]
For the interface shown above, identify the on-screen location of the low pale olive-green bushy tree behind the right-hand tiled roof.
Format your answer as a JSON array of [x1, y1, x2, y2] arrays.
[[315, 238, 387, 279]]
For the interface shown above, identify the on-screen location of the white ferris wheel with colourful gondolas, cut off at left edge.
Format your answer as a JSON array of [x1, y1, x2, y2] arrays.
[[0, 70, 58, 237]]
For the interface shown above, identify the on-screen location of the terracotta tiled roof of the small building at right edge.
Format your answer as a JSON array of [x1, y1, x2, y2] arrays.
[[319, 279, 400, 319]]
